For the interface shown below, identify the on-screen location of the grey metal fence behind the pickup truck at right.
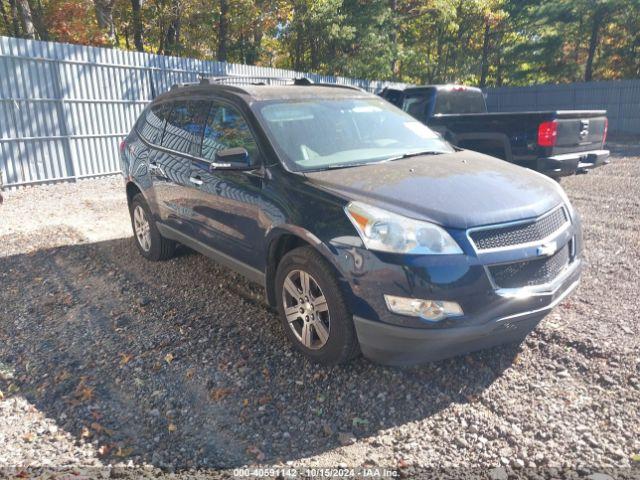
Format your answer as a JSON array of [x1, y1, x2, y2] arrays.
[[486, 80, 640, 135]]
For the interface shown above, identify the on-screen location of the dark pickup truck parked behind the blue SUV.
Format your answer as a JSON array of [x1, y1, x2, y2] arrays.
[[380, 85, 609, 178]]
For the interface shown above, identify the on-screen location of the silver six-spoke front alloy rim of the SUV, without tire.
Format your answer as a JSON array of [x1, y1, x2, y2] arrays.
[[282, 270, 331, 350]]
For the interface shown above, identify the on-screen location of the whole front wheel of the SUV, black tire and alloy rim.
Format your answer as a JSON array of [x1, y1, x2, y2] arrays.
[[275, 247, 360, 365]]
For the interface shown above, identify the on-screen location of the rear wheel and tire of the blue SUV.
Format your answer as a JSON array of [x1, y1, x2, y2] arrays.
[[129, 193, 176, 262]]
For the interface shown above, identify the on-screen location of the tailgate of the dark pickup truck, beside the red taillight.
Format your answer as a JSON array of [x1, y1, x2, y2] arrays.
[[551, 110, 607, 155]]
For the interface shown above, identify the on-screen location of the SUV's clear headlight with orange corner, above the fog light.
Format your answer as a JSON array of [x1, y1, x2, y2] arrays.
[[345, 202, 462, 255]]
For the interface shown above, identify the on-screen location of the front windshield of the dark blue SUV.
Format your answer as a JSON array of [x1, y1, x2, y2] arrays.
[[252, 98, 454, 171]]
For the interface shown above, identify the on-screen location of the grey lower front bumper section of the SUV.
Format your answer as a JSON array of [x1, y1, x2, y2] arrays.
[[353, 261, 582, 366]]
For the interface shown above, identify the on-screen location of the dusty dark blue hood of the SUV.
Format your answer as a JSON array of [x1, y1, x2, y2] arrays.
[[305, 150, 563, 229]]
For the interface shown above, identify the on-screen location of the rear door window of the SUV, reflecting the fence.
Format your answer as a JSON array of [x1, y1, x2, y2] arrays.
[[162, 101, 209, 156]]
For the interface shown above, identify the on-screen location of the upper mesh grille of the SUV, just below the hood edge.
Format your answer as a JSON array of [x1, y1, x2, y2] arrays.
[[469, 208, 568, 250]]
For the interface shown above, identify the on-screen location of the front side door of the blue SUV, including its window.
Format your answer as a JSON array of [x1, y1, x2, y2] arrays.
[[191, 101, 265, 270]]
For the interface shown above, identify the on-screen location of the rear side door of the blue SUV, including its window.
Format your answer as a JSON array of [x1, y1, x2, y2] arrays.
[[149, 100, 206, 235]]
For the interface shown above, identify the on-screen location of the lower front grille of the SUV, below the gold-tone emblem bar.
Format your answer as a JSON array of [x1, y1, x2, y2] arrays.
[[489, 242, 571, 288]]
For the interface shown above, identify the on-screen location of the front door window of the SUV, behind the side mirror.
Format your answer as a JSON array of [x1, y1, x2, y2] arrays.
[[202, 103, 257, 161]]
